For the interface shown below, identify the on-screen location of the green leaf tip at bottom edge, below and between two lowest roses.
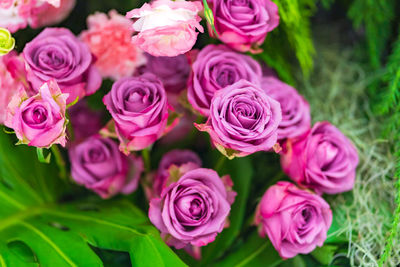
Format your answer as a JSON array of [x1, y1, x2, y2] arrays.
[[216, 231, 283, 267]]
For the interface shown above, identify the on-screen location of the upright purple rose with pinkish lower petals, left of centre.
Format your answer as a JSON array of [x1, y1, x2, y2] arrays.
[[102, 73, 178, 153]]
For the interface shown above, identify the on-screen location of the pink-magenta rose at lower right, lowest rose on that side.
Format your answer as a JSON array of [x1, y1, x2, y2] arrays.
[[255, 182, 332, 259]]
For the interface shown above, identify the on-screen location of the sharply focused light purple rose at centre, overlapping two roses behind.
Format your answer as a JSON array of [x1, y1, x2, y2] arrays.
[[195, 80, 282, 159]]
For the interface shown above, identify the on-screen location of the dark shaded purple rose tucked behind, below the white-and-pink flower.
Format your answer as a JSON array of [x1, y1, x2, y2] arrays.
[[140, 54, 190, 94]]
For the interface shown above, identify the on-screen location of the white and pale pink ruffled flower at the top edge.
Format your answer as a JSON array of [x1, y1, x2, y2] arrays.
[[126, 0, 203, 57]]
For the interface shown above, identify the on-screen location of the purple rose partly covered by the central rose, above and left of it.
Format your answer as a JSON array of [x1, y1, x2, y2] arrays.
[[188, 45, 262, 116]]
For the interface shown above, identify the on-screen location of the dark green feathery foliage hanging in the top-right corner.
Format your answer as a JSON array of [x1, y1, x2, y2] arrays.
[[348, 0, 396, 68]]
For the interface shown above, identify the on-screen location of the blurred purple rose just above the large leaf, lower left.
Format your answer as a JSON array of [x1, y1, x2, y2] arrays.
[[69, 135, 144, 198]]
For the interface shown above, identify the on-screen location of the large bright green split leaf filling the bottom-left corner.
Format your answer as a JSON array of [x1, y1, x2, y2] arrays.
[[0, 134, 184, 267]]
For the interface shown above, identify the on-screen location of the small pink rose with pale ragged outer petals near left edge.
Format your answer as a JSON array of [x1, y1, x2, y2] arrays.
[[4, 80, 68, 148]]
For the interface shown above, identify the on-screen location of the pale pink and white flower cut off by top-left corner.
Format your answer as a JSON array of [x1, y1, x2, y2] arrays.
[[0, 0, 76, 32]]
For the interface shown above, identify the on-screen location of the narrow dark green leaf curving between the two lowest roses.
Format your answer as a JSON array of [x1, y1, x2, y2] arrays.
[[201, 157, 253, 265]]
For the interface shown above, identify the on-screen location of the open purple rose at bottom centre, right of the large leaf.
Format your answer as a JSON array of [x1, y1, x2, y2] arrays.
[[149, 168, 236, 249]]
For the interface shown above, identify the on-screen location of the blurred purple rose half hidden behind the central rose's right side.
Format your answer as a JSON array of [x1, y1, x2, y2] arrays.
[[261, 77, 311, 140]]
